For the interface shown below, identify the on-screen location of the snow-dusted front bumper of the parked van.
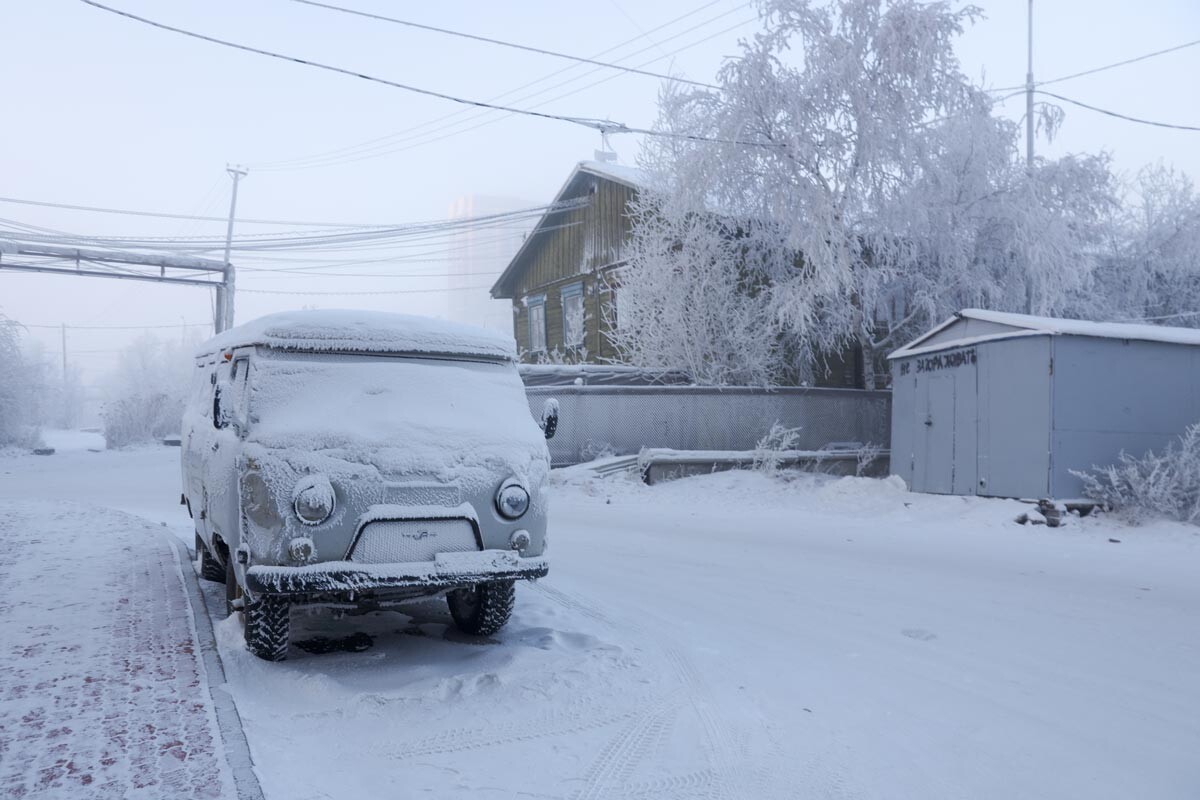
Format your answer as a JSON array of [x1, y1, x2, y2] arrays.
[[246, 551, 550, 596]]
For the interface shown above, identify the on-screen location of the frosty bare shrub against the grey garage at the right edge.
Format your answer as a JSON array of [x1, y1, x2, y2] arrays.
[[1072, 423, 1200, 524]]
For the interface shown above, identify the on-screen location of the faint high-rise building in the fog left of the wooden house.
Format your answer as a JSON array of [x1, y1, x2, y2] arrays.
[[444, 194, 536, 333]]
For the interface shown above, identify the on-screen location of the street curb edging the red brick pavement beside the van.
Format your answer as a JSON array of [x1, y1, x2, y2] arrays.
[[167, 534, 264, 800]]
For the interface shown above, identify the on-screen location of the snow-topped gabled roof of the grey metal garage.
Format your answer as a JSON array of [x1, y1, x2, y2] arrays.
[[888, 308, 1200, 359]]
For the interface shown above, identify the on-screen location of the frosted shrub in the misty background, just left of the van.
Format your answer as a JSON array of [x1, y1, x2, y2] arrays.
[[101, 336, 192, 447]]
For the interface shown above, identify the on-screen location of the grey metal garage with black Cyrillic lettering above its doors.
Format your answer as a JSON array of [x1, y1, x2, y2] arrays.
[[888, 308, 1200, 500]]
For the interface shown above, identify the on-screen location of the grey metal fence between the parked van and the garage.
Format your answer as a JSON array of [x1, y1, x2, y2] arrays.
[[526, 385, 892, 467]]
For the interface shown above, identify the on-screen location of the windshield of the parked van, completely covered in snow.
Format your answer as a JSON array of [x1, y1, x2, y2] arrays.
[[250, 354, 540, 449]]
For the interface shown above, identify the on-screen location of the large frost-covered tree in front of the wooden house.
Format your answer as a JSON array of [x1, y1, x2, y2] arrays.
[[613, 0, 1112, 385]]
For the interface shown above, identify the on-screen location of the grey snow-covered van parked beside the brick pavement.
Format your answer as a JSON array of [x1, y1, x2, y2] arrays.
[[182, 311, 558, 661]]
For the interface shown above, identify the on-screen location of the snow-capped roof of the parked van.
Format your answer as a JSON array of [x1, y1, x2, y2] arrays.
[[196, 309, 516, 361]]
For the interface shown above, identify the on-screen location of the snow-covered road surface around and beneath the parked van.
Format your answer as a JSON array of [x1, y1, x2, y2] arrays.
[[0, 447, 1200, 800]]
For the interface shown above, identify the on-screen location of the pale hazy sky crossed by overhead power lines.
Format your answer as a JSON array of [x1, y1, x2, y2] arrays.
[[0, 0, 1200, 379]]
